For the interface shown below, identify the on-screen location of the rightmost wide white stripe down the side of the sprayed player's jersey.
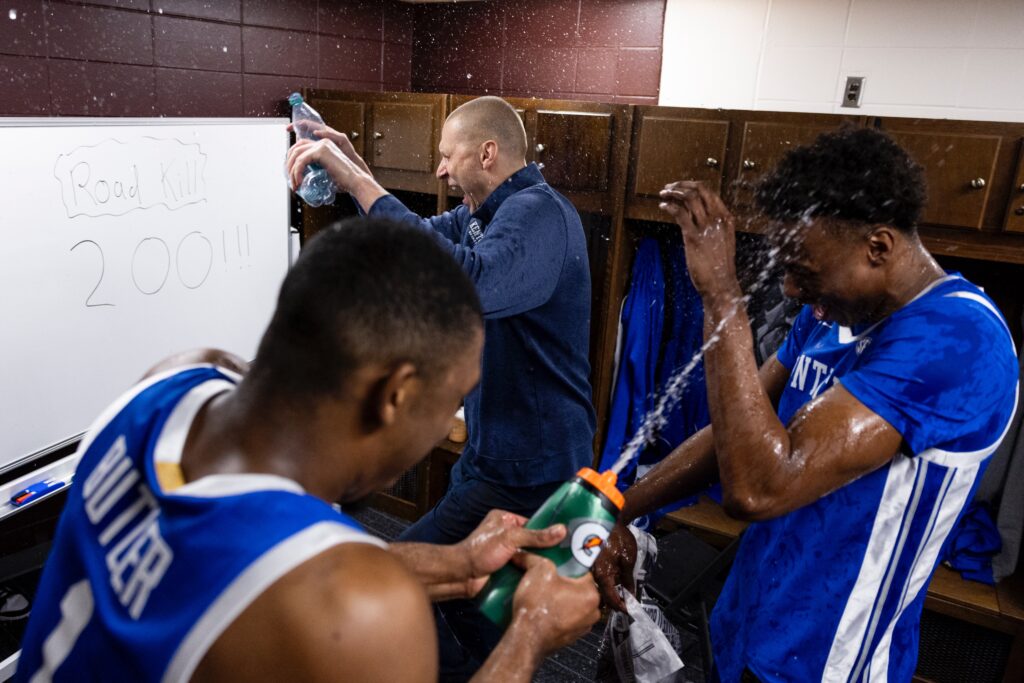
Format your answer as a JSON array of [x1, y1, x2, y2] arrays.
[[871, 465, 980, 681]]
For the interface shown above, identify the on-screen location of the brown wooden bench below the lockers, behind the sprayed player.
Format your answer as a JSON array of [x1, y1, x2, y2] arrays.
[[666, 496, 1024, 683]]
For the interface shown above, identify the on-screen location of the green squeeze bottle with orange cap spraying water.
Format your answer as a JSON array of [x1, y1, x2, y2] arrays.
[[476, 467, 625, 629]]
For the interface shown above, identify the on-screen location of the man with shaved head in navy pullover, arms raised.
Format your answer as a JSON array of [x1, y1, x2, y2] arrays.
[[287, 97, 594, 680]]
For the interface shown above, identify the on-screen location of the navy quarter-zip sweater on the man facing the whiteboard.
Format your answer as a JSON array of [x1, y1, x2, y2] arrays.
[[369, 164, 595, 486]]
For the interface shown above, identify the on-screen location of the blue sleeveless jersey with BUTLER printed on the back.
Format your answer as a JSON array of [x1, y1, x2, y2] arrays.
[[16, 366, 383, 683]]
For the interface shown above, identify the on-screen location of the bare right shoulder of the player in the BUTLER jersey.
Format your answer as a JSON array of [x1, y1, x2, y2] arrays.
[[197, 543, 434, 681]]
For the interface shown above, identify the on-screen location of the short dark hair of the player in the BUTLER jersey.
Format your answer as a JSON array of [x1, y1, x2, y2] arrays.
[[250, 218, 483, 402]]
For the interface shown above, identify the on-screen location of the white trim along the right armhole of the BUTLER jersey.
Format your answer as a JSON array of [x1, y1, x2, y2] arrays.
[[163, 522, 387, 683]]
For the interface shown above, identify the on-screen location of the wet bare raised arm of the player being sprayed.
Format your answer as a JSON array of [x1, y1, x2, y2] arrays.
[[662, 182, 902, 519]]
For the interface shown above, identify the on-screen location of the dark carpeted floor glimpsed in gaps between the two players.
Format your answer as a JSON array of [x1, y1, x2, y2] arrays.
[[349, 508, 703, 683]]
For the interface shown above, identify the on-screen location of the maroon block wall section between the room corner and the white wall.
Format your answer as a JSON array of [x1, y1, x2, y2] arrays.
[[413, 0, 665, 104]]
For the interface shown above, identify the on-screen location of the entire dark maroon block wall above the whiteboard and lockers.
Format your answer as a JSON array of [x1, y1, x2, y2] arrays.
[[0, 0, 665, 116]]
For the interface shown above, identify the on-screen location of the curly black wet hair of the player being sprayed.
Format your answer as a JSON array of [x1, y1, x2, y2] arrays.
[[754, 127, 926, 233]]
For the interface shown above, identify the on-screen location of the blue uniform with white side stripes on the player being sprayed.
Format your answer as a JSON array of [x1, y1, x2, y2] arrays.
[[712, 275, 1018, 683]]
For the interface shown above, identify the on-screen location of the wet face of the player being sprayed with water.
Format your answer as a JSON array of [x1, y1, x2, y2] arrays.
[[771, 218, 884, 327]]
